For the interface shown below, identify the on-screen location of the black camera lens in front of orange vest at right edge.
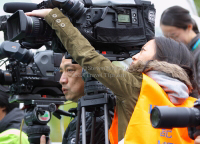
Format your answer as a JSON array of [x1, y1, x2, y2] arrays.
[[150, 99, 200, 139]]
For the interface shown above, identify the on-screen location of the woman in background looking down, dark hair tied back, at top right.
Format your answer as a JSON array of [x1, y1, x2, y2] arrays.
[[160, 6, 200, 93]]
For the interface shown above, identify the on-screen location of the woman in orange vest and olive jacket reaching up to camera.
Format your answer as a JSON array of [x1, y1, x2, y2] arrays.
[[27, 8, 196, 144]]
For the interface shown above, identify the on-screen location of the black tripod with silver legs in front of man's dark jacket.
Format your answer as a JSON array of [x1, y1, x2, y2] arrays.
[[65, 51, 129, 144]]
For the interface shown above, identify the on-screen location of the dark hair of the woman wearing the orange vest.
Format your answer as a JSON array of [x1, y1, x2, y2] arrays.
[[154, 37, 197, 97]]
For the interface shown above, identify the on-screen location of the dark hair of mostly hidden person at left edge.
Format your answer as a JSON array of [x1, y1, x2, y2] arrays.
[[0, 85, 19, 114]]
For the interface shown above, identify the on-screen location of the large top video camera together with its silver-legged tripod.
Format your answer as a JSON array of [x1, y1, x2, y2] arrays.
[[1, 0, 155, 144]]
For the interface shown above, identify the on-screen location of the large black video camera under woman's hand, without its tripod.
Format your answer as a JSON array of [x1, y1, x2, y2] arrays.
[[4, 0, 155, 52]]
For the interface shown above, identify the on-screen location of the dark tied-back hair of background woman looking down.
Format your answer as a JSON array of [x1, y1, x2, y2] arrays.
[[160, 6, 199, 34]]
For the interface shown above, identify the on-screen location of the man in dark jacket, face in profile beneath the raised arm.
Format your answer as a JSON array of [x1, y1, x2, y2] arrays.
[[60, 56, 105, 144]]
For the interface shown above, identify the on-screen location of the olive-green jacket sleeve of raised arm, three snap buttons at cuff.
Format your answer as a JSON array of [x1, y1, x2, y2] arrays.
[[45, 8, 142, 99]]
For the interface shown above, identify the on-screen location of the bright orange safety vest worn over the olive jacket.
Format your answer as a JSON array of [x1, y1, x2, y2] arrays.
[[109, 74, 196, 144]]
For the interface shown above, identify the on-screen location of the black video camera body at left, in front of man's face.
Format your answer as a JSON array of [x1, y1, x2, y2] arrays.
[[0, 41, 63, 101]]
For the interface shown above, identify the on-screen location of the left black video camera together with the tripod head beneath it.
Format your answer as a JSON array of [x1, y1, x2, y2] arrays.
[[0, 41, 74, 144]]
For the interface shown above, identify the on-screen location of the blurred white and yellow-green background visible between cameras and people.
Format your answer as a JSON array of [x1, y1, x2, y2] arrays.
[[0, 0, 200, 144]]
